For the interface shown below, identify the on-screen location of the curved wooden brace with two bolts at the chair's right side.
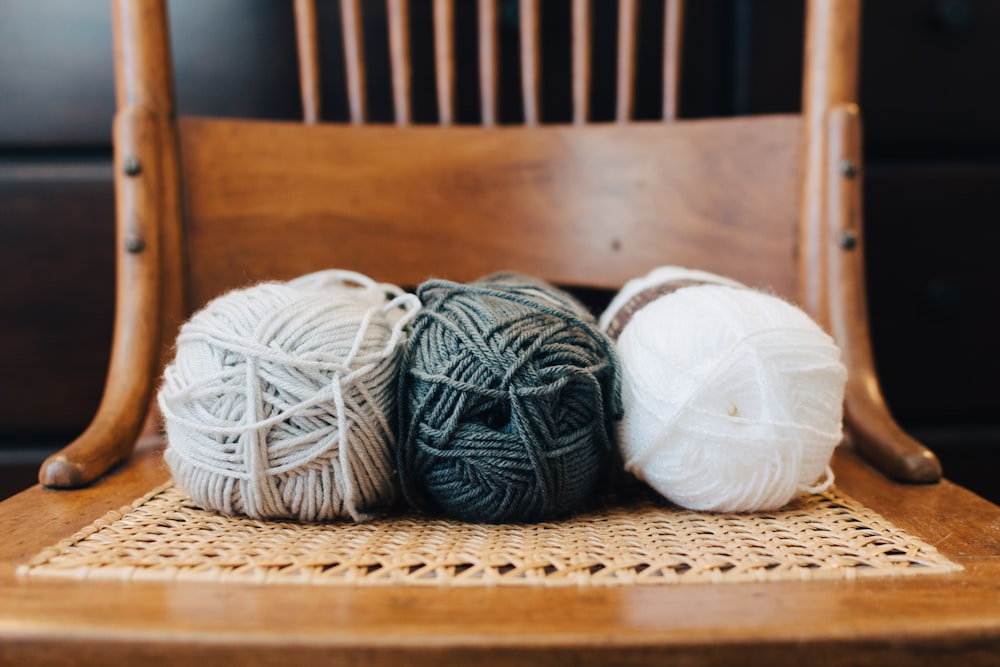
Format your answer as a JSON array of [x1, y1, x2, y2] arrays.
[[827, 104, 941, 483]]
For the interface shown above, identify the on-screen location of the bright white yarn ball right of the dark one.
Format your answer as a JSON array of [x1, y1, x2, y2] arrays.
[[600, 267, 847, 512]]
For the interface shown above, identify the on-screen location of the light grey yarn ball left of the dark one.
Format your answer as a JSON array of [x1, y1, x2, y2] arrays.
[[157, 271, 420, 521]]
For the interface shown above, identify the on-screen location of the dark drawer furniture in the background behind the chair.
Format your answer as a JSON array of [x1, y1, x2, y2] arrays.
[[0, 0, 1000, 501]]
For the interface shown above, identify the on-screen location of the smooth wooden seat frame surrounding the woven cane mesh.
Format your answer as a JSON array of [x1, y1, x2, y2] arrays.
[[0, 438, 1000, 667]]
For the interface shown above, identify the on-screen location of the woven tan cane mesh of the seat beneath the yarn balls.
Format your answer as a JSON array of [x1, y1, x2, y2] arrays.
[[21, 485, 961, 586]]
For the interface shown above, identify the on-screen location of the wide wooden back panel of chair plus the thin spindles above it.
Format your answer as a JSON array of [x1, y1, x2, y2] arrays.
[[178, 0, 802, 309]]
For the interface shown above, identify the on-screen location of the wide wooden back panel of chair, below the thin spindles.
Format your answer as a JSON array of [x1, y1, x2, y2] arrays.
[[180, 116, 802, 307]]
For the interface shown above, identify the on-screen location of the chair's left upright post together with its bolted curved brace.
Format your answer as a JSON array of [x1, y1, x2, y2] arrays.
[[39, 0, 186, 488]]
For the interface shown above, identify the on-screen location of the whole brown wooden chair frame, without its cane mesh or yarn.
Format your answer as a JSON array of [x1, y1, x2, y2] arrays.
[[0, 0, 1000, 665]]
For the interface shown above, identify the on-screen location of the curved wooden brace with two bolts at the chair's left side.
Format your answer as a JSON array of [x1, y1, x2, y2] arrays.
[[38, 109, 161, 488]]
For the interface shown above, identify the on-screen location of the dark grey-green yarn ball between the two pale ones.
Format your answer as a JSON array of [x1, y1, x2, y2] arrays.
[[398, 274, 621, 523]]
